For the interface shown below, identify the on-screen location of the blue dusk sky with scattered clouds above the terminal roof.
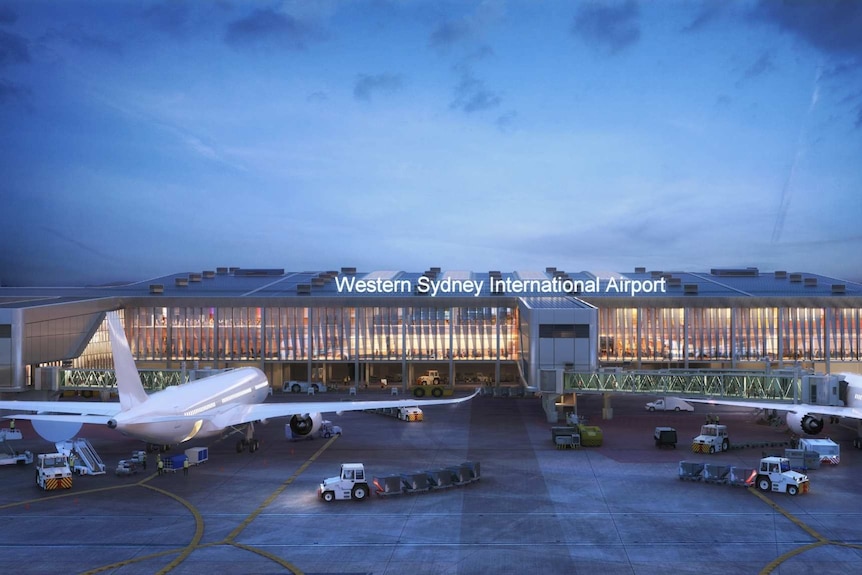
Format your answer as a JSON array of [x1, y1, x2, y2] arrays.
[[0, 0, 862, 286]]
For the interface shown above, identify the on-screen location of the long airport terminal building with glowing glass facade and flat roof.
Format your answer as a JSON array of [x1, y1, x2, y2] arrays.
[[0, 268, 862, 392]]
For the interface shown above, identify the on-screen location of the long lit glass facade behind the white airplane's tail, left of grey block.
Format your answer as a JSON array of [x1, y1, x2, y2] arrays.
[[113, 306, 518, 362]]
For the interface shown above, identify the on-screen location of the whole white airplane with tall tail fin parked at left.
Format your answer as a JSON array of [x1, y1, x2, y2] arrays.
[[0, 312, 479, 452]]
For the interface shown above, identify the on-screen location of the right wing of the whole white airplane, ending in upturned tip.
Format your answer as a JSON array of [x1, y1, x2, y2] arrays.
[[211, 389, 480, 427]]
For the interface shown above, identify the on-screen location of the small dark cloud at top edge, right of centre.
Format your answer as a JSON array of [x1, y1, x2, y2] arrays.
[[572, 0, 641, 54]]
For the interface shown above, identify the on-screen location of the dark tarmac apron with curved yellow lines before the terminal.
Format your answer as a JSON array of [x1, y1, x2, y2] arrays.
[[0, 390, 862, 575]]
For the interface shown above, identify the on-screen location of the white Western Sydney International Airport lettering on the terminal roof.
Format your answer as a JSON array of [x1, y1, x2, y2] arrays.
[[335, 276, 667, 297]]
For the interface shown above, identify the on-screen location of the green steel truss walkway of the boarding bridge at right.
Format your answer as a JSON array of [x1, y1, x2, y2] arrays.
[[563, 369, 808, 403]]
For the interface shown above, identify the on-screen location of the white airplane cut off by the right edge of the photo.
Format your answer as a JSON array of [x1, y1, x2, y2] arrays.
[[685, 373, 862, 448]]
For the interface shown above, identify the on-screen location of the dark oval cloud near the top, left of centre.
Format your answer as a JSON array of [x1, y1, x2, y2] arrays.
[[224, 8, 316, 50]]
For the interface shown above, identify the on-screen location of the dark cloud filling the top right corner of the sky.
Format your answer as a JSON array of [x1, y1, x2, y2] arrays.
[[754, 0, 862, 58]]
